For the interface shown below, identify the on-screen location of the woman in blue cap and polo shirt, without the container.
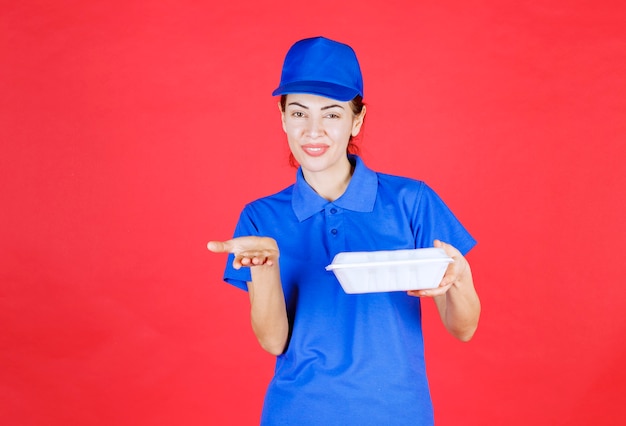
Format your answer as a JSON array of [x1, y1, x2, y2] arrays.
[[208, 37, 480, 425]]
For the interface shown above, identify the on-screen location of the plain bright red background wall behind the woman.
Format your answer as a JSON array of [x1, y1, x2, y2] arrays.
[[0, 0, 626, 425]]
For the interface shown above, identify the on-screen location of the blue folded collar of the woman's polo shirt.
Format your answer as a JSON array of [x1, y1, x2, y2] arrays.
[[291, 155, 378, 222]]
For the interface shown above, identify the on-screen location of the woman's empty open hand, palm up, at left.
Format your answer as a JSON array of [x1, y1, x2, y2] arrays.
[[207, 236, 279, 269]]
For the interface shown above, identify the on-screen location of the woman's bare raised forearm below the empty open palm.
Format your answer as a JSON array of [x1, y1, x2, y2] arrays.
[[248, 263, 289, 355]]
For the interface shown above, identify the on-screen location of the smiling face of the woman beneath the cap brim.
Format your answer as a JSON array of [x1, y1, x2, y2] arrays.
[[279, 94, 365, 177]]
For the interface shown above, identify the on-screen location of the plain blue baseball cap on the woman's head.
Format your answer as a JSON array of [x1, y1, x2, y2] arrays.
[[272, 37, 363, 102]]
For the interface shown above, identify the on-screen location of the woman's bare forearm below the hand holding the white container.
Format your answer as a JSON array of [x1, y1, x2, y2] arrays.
[[435, 264, 480, 342]]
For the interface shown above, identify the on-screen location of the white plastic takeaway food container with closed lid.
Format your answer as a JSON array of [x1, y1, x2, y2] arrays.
[[326, 248, 453, 294]]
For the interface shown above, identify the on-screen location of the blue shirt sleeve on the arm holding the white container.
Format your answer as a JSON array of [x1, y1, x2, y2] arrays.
[[413, 182, 476, 256]]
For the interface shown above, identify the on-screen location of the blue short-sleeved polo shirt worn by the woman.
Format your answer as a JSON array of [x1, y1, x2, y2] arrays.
[[224, 157, 475, 426]]
